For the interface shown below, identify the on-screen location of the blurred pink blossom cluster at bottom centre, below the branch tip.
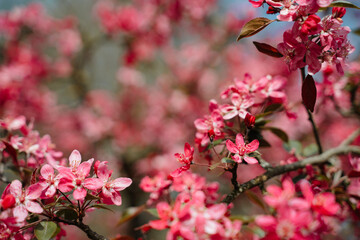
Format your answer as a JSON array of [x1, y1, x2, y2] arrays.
[[142, 173, 242, 240]]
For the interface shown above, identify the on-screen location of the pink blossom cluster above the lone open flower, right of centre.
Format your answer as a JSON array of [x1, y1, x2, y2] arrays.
[[194, 73, 287, 149]]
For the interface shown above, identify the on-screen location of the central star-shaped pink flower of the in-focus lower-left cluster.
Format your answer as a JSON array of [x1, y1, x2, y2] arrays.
[[58, 150, 103, 200]]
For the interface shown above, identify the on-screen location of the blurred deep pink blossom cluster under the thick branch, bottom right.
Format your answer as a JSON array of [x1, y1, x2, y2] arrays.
[[255, 178, 340, 239]]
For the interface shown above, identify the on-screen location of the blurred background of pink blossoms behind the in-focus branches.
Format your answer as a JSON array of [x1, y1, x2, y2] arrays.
[[0, 0, 360, 239]]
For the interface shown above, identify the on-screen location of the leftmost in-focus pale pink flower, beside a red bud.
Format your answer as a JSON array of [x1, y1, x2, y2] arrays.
[[9, 180, 43, 222]]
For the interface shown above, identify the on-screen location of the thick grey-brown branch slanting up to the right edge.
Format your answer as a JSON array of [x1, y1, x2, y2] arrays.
[[223, 145, 360, 203]]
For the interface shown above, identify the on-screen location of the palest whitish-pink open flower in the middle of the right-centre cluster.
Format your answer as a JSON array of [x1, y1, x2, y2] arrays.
[[220, 93, 254, 120]]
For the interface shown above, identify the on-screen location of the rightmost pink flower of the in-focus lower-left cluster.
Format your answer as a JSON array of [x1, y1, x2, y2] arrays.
[[96, 161, 132, 206]]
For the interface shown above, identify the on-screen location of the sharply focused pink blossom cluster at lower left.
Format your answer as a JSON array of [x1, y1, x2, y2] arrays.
[[0, 146, 132, 239]]
